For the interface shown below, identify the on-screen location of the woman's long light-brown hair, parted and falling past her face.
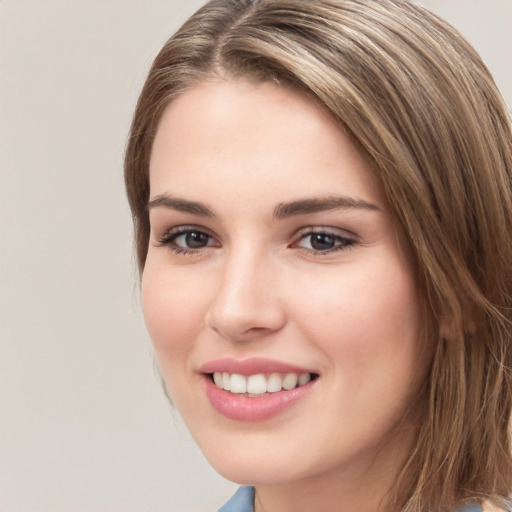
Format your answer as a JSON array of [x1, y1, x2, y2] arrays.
[[125, 0, 512, 512]]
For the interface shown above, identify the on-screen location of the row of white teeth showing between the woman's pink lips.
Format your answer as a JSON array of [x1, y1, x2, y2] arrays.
[[211, 372, 315, 398]]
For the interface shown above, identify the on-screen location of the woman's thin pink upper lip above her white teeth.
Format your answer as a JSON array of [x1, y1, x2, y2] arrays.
[[199, 357, 314, 375]]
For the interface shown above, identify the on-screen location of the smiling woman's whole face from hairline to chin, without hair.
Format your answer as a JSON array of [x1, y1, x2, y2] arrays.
[[143, 81, 430, 485]]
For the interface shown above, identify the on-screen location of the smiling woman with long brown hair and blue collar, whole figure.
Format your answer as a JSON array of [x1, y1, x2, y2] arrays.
[[125, 0, 512, 512]]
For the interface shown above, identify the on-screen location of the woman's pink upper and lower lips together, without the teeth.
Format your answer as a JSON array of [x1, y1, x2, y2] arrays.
[[200, 358, 318, 422]]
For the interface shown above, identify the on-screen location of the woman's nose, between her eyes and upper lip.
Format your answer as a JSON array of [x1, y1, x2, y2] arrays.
[[206, 246, 286, 341]]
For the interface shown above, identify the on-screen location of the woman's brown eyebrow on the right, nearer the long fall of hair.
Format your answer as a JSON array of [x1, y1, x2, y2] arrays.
[[274, 196, 380, 219]]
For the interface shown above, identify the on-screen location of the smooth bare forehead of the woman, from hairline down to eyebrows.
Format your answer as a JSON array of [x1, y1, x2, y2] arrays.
[[150, 81, 380, 208]]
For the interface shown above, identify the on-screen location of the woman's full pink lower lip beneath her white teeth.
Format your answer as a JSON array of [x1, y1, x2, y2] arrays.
[[204, 375, 316, 422]]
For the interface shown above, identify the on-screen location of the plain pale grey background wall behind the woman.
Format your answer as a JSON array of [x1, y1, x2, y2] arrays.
[[0, 0, 512, 512]]
